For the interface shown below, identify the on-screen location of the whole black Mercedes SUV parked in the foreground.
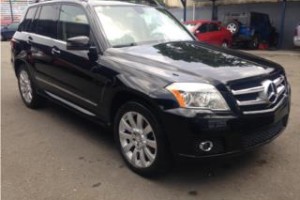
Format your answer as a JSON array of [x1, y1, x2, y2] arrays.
[[11, 1, 290, 175]]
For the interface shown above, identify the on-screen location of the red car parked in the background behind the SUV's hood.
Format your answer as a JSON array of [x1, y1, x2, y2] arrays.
[[184, 20, 232, 48]]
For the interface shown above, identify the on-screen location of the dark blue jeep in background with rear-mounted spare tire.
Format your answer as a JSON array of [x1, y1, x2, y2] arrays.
[[224, 12, 278, 49]]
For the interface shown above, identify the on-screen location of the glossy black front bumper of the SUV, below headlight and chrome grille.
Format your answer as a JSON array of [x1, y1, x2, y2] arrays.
[[162, 94, 290, 158]]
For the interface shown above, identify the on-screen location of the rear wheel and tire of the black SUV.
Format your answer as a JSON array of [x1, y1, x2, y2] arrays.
[[17, 65, 45, 109]]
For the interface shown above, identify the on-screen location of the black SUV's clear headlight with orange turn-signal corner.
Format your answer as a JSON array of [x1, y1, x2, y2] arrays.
[[166, 83, 229, 110]]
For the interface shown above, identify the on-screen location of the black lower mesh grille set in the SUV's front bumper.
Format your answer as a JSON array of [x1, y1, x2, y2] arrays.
[[242, 121, 284, 148]]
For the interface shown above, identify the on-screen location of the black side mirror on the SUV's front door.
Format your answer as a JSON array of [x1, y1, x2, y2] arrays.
[[67, 36, 90, 51]]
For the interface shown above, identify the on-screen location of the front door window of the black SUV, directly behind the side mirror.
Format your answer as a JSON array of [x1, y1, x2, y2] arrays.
[[58, 5, 90, 41]]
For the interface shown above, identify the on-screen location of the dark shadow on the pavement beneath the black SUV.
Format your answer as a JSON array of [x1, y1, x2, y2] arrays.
[[44, 103, 266, 181]]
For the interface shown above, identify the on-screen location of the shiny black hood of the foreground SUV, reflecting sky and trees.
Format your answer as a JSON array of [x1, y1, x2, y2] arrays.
[[106, 41, 282, 84]]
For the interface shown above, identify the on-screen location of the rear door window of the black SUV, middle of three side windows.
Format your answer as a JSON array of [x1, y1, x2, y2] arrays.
[[35, 5, 58, 38]]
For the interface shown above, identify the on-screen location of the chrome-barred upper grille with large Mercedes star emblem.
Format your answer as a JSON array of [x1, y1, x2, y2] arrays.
[[231, 74, 288, 115]]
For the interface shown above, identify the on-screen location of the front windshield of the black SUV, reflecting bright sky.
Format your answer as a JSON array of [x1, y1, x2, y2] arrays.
[[95, 5, 193, 47]]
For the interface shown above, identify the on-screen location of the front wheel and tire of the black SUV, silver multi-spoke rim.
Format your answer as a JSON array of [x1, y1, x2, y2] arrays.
[[114, 102, 170, 177]]
